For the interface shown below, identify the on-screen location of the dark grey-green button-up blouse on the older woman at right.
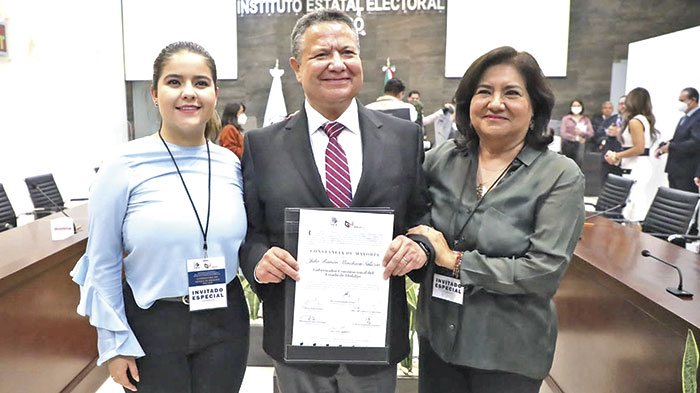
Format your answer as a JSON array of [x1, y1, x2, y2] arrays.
[[418, 142, 584, 379]]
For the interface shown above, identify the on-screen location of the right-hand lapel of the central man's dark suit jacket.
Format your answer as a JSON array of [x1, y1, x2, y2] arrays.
[[350, 102, 387, 207]]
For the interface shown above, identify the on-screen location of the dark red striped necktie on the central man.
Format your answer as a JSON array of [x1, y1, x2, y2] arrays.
[[321, 122, 352, 207]]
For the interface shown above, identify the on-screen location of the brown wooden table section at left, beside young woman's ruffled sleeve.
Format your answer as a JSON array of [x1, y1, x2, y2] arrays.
[[0, 204, 109, 393]]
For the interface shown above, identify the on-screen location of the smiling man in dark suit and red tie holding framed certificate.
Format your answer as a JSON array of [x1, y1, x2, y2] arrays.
[[240, 9, 432, 393]]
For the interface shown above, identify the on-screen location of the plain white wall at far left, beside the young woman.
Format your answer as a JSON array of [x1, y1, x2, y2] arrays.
[[0, 0, 127, 220]]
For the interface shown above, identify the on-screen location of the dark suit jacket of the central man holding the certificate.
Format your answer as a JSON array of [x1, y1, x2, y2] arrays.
[[240, 104, 430, 375]]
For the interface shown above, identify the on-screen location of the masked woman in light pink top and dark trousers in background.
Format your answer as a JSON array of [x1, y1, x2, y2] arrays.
[[561, 100, 593, 168]]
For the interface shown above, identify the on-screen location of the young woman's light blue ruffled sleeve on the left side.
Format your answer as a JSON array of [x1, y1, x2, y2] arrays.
[[70, 151, 145, 366]]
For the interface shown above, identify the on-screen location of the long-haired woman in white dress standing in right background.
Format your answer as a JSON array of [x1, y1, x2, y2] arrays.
[[605, 87, 659, 222]]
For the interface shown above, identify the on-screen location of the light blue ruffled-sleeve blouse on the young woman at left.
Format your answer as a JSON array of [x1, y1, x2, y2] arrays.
[[71, 136, 246, 365]]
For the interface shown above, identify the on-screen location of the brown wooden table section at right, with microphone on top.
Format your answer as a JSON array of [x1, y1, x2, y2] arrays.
[[547, 217, 700, 393]]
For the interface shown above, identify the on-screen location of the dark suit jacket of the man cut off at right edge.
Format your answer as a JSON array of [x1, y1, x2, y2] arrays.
[[666, 109, 700, 181]]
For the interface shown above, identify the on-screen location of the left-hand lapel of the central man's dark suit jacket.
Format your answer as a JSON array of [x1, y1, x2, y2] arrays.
[[284, 109, 333, 207]]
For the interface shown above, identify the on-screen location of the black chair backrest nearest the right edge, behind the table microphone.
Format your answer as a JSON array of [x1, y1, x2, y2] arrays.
[[642, 187, 700, 238]]
